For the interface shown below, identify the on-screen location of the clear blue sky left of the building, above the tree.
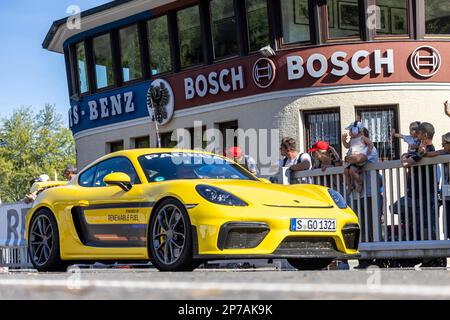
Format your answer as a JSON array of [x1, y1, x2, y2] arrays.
[[0, 0, 111, 123]]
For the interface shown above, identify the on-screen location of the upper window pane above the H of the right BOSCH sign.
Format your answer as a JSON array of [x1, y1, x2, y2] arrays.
[[376, 0, 409, 35]]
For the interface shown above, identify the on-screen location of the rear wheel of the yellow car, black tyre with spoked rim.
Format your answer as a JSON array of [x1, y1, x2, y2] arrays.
[[28, 209, 68, 272]]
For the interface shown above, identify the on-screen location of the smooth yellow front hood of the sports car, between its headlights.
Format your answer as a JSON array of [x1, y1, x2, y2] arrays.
[[196, 180, 334, 208]]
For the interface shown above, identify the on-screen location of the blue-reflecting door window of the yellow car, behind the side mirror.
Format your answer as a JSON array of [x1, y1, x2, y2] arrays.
[[93, 157, 141, 187]]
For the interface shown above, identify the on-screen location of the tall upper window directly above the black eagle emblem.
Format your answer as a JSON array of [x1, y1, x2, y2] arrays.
[[147, 16, 172, 75]]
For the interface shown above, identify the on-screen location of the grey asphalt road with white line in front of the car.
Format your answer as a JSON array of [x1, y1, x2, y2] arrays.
[[0, 260, 450, 300]]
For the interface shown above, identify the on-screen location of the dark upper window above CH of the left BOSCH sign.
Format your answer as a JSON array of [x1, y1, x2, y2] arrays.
[[210, 0, 238, 59]]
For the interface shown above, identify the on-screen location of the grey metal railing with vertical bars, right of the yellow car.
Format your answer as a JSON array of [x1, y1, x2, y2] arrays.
[[280, 156, 450, 259]]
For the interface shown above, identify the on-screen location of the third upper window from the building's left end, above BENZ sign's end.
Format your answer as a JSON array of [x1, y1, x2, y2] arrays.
[[119, 24, 142, 82]]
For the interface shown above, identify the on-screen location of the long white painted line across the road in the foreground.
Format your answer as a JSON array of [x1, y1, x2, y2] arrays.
[[0, 279, 450, 298]]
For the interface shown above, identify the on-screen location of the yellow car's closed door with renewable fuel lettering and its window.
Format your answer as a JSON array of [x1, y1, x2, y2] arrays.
[[72, 157, 152, 248]]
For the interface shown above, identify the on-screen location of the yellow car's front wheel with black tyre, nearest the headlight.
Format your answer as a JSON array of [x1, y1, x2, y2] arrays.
[[148, 199, 202, 271]]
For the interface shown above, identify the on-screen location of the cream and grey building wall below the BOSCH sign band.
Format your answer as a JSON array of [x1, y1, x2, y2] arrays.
[[76, 87, 450, 176]]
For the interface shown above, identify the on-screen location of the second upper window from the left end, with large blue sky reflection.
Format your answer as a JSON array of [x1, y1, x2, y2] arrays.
[[93, 34, 114, 89]]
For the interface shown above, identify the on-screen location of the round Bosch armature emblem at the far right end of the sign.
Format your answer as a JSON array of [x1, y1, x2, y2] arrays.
[[410, 46, 442, 78]]
